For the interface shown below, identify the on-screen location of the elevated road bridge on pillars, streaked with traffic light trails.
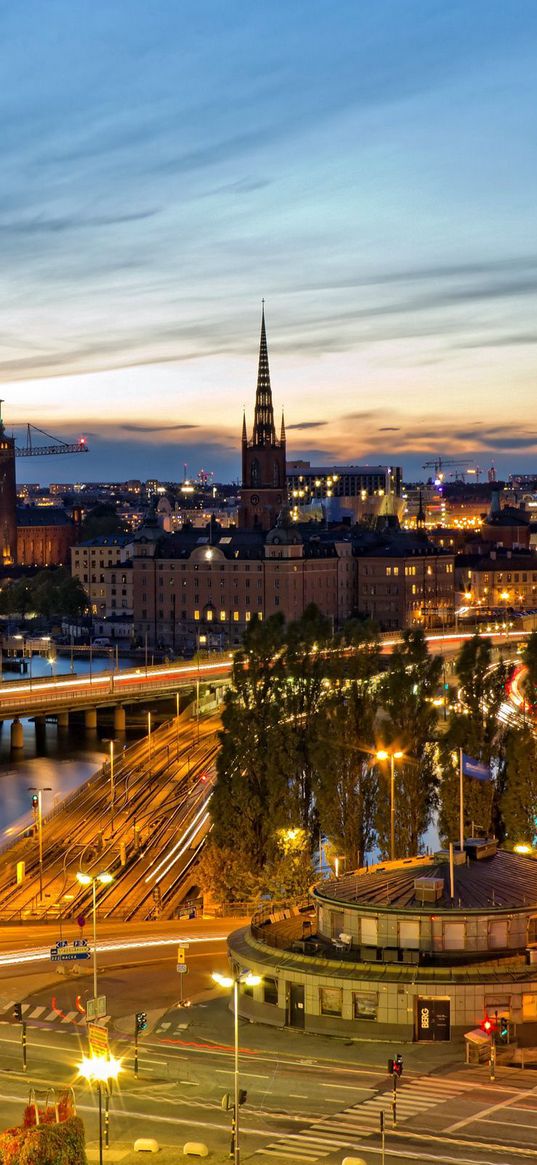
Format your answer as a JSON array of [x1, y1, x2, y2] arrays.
[[0, 628, 529, 748]]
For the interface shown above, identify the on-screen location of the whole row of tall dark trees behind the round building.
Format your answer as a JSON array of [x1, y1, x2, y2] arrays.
[[200, 607, 537, 899]]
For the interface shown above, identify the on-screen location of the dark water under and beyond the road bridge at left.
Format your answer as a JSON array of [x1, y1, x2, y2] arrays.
[[0, 656, 141, 845]]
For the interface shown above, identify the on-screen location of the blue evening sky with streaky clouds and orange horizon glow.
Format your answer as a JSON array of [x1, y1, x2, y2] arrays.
[[0, 0, 537, 482]]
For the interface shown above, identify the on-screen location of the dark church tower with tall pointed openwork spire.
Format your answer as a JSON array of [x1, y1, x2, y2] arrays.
[[239, 301, 287, 530]]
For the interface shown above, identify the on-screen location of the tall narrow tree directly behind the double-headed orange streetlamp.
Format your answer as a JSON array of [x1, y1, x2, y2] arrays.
[[377, 628, 441, 857]]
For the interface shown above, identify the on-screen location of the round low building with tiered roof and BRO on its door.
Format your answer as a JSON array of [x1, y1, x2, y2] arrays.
[[228, 841, 537, 1040]]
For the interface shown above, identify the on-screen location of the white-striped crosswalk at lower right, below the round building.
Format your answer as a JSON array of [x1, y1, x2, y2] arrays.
[[254, 1076, 464, 1162]]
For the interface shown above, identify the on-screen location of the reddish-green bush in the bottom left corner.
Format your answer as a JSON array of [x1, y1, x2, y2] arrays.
[[0, 1116, 87, 1165]]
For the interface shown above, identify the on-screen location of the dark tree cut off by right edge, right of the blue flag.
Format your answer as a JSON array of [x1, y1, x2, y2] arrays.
[[500, 726, 537, 846]]
